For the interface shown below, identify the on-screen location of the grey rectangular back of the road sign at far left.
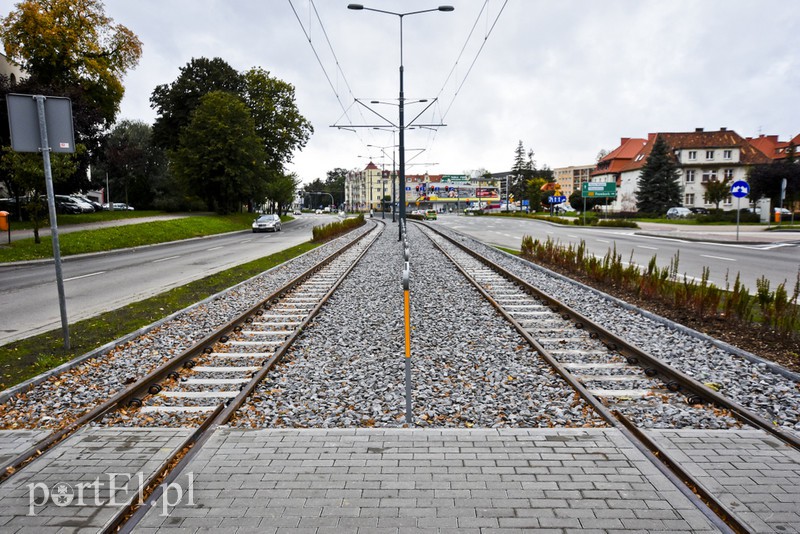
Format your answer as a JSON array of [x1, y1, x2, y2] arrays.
[[6, 94, 75, 153]]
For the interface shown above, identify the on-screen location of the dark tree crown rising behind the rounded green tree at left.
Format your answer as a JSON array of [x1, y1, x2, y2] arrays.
[[150, 57, 244, 149]]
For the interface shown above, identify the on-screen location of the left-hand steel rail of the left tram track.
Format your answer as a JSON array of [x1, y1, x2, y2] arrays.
[[0, 222, 370, 484]]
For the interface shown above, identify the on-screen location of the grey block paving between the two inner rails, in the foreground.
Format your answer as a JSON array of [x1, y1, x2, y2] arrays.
[[137, 429, 715, 532]]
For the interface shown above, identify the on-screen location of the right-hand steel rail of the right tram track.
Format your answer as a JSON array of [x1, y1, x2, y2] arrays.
[[416, 223, 800, 451]]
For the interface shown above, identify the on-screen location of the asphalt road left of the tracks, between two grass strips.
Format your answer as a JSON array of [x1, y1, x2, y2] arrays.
[[0, 214, 336, 345]]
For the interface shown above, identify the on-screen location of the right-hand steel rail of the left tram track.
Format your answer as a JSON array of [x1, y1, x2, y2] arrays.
[[107, 223, 386, 533]]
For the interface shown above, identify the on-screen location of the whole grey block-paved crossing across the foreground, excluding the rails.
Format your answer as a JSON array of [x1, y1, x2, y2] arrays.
[[0, 427, 800, 534]]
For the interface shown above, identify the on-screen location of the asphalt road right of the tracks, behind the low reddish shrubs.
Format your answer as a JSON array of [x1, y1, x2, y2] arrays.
[[437, 214, 800, 294]]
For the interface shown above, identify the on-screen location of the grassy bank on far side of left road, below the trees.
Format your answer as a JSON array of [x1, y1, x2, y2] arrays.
[[0, 213, 254, 262]]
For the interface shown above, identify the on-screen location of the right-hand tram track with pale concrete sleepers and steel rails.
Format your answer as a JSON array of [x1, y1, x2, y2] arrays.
[[420, 220, 800, 533]]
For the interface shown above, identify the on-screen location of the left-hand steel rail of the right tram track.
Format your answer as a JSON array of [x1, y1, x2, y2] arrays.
[[426, 225, 751, 533]]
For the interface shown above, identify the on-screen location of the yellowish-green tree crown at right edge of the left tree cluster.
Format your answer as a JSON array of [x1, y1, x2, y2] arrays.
[[241, 68, 314, 170]]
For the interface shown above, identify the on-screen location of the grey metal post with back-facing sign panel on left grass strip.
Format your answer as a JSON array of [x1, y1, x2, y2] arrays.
[[6, 94, 75, 350]]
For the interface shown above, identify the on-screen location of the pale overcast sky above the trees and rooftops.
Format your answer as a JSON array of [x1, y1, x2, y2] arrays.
[[95, 0, 800, 183]]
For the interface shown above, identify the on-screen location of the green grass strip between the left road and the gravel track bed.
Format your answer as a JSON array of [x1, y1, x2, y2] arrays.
[[0, 242, 320, 390]]
